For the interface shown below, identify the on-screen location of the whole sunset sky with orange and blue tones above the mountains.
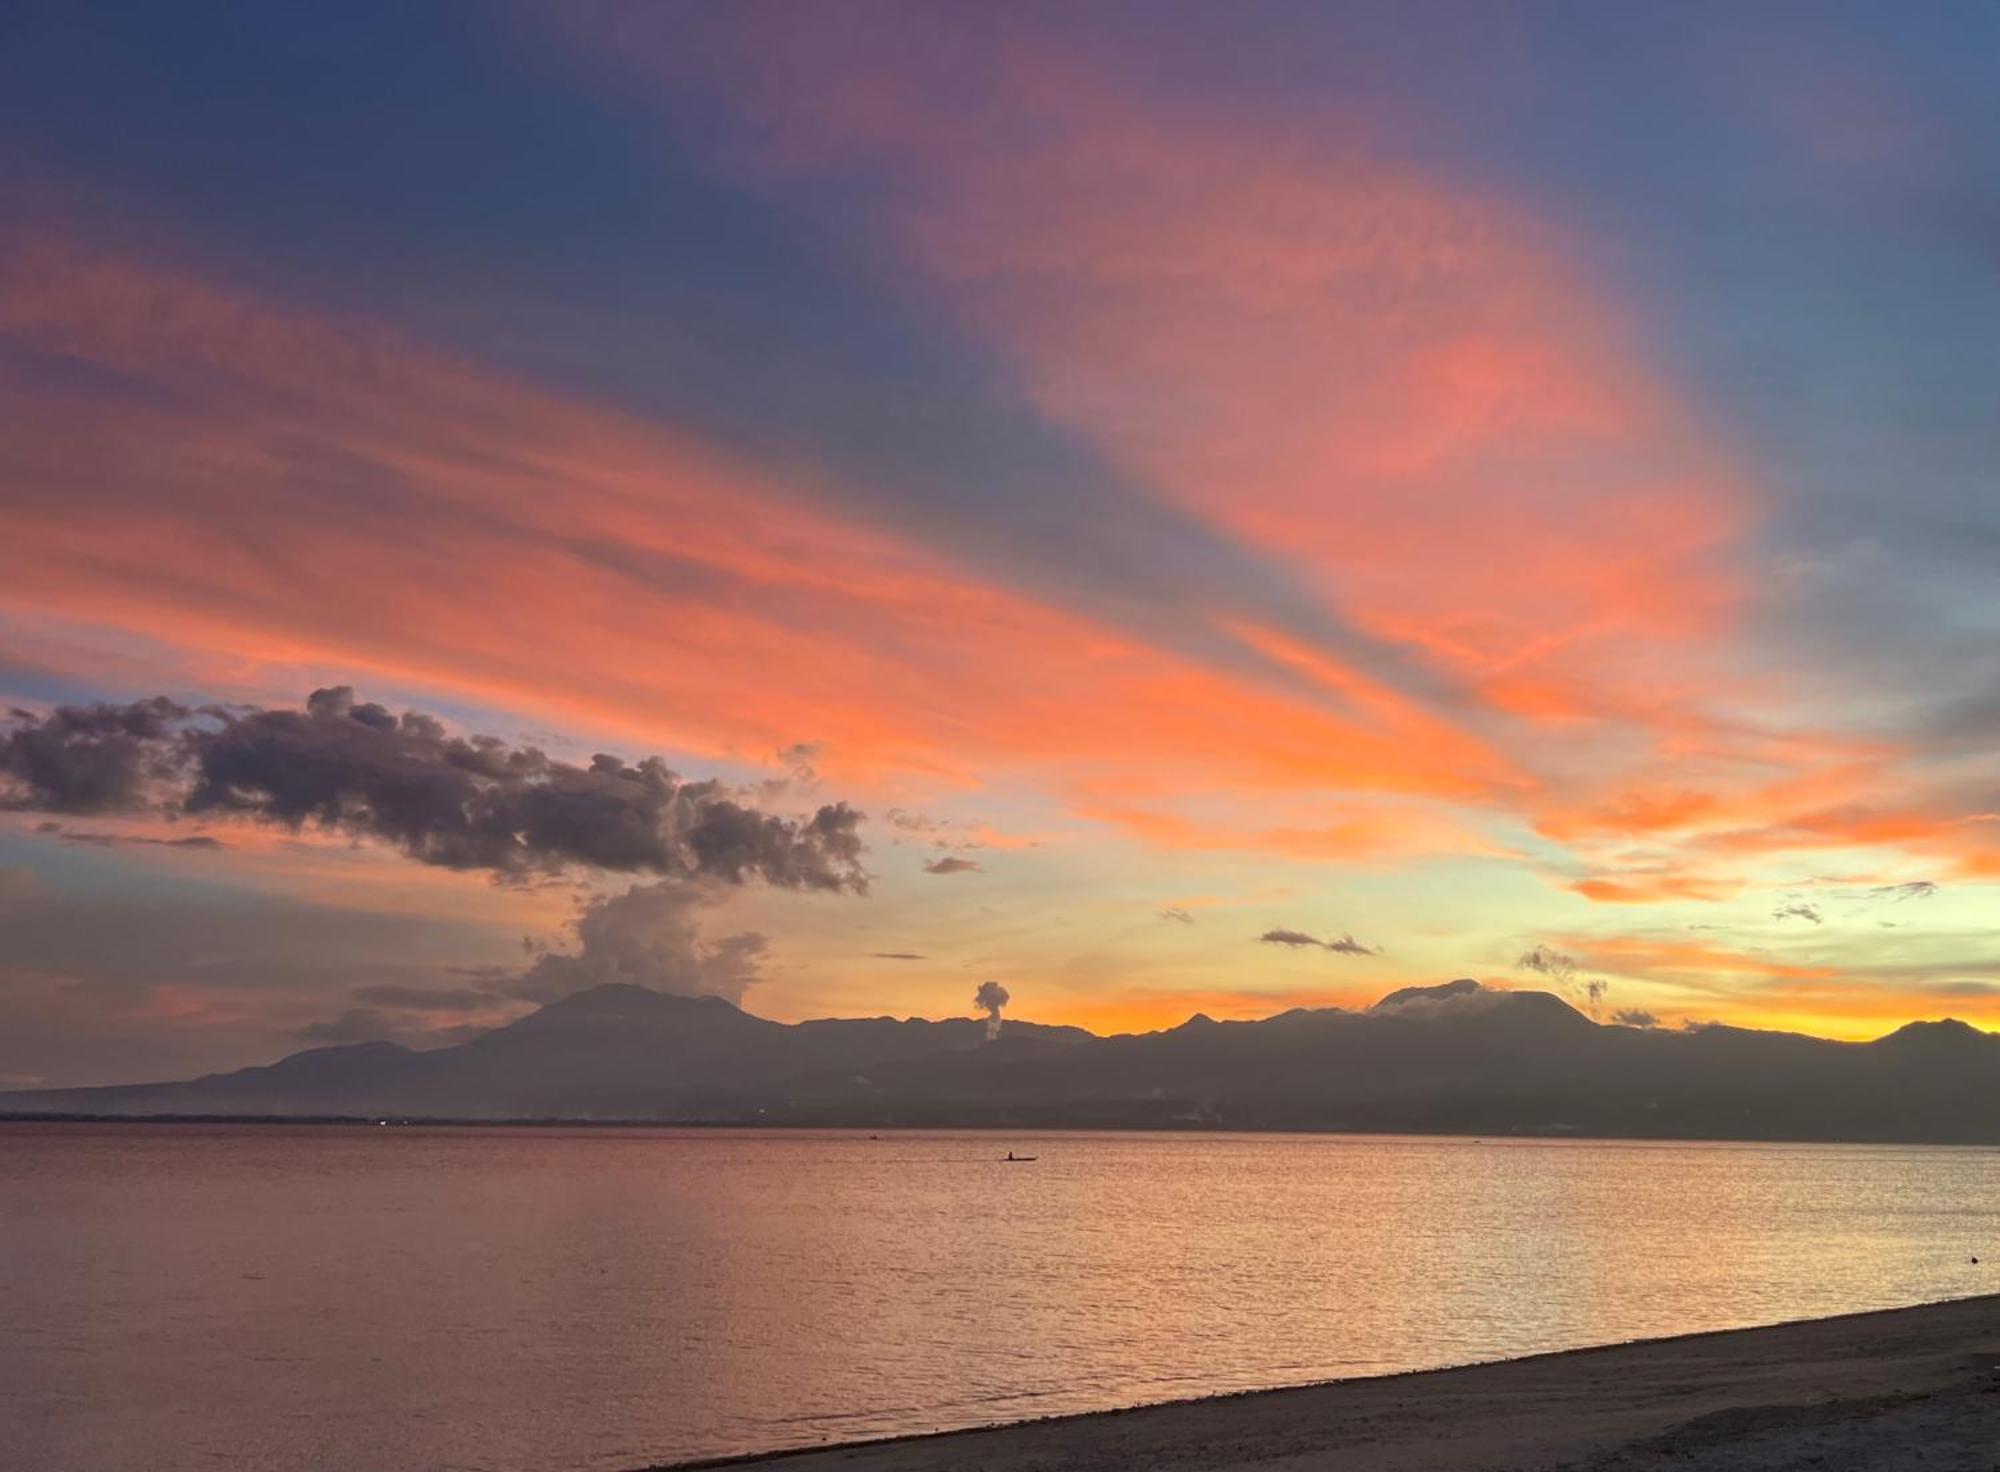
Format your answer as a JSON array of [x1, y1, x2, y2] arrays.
[[0, 0, 2000, 1086]]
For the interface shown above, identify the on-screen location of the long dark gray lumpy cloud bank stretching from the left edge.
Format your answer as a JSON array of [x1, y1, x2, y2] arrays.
[[0, 686, 868, 892]]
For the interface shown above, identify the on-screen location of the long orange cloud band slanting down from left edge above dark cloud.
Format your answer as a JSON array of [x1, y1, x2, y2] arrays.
[[0, 229, 1560, 840]]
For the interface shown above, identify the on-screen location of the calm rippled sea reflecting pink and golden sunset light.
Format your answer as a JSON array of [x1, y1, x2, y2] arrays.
[[0, 1124, 2000, 1472]]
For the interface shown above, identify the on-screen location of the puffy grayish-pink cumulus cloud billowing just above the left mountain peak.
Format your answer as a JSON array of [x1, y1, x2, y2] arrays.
[[508, 880, 768, 1002]]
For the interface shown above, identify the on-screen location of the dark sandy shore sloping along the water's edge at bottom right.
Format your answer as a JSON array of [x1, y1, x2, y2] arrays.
[[664, 1296, 2000, 1472]]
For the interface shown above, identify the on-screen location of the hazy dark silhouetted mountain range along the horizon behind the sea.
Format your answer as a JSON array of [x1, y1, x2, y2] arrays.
[[15, 980, 2000, 1144]]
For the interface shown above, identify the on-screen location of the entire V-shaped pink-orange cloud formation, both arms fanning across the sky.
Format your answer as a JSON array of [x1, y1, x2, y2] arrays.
[[0, 5, 2000, 1000]]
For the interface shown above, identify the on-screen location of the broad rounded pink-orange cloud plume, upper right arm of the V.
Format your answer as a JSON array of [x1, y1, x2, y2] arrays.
[[618, 16, 1754, 714]]
